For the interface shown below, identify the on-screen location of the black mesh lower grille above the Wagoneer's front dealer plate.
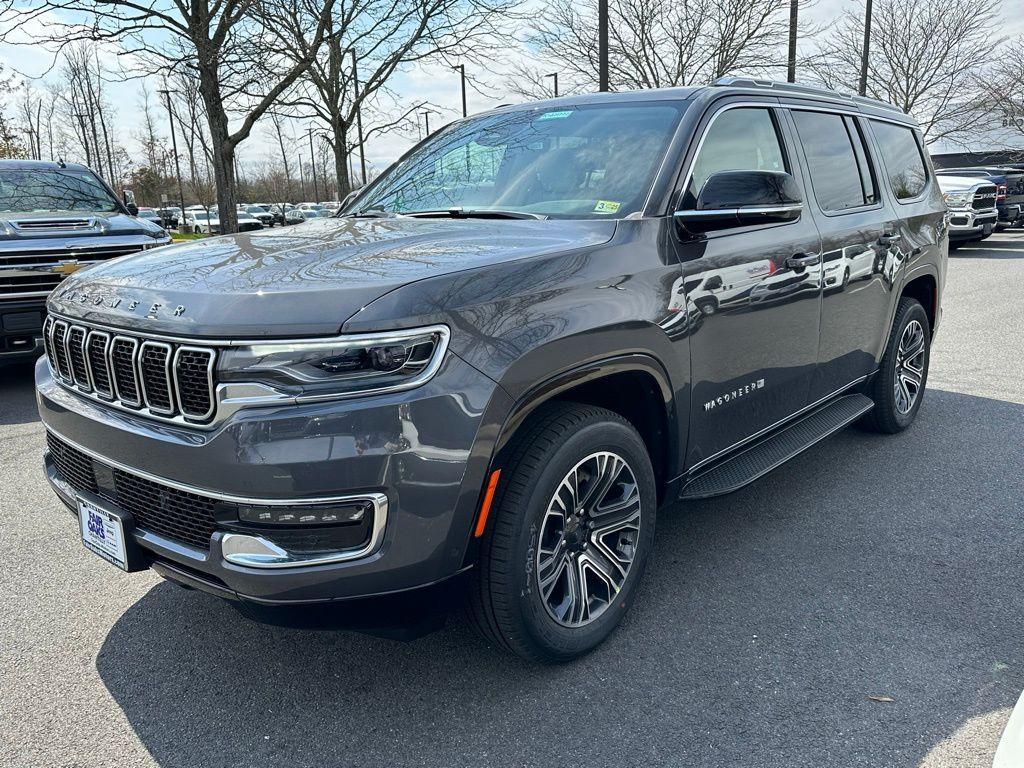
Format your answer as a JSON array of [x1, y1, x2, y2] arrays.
[[46, 432, 216, 551]]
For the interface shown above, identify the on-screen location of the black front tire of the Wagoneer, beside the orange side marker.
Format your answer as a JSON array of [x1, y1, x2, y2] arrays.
[[468, 402, 657, 664]]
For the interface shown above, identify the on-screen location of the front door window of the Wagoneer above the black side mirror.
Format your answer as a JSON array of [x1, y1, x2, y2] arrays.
[[683, 108, 787, 208]]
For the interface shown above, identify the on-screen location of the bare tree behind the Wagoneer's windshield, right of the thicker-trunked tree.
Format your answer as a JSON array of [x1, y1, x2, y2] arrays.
[[284, 0, 518, 197]]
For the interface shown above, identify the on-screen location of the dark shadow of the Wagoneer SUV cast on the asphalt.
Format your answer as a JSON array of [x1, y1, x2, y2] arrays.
[[97, 390, 1024, 768]]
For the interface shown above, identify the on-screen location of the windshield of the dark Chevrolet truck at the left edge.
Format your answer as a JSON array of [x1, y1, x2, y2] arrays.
[[0, 168, 121, 213]]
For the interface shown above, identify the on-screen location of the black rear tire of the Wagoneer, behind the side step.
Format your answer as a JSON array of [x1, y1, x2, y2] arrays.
[[862, 297, 932, 434]]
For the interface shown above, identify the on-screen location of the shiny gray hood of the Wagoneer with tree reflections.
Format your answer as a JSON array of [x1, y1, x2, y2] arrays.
[[49, 218, 615, 338]]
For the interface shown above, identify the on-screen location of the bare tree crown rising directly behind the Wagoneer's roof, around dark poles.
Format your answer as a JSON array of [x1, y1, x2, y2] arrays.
[[513, 0, 790, 97]]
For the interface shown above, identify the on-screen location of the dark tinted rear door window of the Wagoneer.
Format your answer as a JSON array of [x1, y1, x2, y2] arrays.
[[793, 112, 876, 211]]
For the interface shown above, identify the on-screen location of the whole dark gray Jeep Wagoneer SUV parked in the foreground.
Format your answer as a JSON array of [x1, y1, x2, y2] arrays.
[[36, 79, 948, 660]]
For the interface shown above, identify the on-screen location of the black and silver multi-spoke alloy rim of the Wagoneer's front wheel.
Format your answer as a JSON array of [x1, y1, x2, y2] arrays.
[[535, 451, 641, 627]]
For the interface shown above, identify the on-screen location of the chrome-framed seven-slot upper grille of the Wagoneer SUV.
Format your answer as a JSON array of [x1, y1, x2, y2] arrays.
[[43, 317, 216, 423]]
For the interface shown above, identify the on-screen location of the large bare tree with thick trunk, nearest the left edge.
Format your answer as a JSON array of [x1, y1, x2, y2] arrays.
[[0, 0, 344, 231]]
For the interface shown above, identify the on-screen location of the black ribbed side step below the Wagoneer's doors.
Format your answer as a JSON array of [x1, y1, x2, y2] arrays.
[[679, 394, 874, 500]]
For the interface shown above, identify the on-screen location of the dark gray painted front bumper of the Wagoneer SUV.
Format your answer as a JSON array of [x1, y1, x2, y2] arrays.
[[36, 352, 511, 605]]
